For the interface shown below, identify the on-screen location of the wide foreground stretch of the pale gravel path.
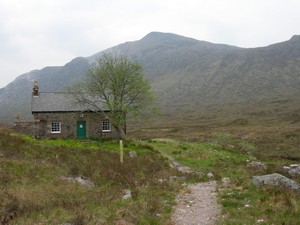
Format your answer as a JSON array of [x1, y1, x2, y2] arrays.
[[172, 181, 220, 225]]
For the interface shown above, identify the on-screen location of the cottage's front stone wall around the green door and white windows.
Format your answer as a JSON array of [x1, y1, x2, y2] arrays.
[[33, 112, 118, 139]]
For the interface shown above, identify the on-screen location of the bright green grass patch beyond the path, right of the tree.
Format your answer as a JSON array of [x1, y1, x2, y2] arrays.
[[151, 140, 251, 180]]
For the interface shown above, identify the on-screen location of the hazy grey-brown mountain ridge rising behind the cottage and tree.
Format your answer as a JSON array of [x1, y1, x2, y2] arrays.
[[0, 32, 300, 122]]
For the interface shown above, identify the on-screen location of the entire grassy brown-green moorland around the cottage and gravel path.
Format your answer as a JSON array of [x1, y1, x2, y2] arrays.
[[0, 100, 300, 225]]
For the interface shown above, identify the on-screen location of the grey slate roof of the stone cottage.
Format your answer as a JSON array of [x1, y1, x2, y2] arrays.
[[31, 92, 105, 113]]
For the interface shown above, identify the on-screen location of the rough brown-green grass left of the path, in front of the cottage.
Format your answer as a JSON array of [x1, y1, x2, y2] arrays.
[[0, 129, 184, 224]]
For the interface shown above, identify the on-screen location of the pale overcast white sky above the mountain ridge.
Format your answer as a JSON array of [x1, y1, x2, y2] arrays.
[[0, 0, 300, 88]]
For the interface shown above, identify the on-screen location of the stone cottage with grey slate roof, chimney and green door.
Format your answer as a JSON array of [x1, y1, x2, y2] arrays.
[[31, 81, 118, 139]]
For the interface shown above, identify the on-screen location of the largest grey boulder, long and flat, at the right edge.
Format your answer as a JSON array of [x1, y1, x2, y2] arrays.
[[252, 173, 300, 191]]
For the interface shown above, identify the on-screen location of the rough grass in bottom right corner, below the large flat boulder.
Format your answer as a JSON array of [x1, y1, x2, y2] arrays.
[[220, 184, 300, 225]]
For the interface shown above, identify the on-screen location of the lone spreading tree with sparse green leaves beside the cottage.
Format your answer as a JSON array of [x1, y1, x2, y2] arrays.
[[73, 53, 154, 138]]
